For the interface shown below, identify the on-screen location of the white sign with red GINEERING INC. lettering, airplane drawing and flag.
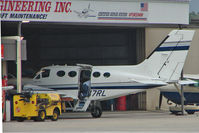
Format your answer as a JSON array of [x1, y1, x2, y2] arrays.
[[0, 0, 148, 23]]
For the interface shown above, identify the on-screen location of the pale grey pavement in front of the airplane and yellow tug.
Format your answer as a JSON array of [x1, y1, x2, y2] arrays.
[[3, 111, 199, 133]]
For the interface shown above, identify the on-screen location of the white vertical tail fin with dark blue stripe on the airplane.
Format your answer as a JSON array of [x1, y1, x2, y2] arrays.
[[143, 30, 195, 82]]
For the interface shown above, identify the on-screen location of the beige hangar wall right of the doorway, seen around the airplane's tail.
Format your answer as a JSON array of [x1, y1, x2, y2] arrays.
[[145, 28, 199, 110]]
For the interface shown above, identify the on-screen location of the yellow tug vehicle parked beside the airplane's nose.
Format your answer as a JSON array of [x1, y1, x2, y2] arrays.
[[13, 92, 62, 122]]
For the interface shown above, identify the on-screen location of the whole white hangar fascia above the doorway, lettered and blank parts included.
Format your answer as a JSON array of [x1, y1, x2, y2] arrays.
[[0, 0, 189, 25]]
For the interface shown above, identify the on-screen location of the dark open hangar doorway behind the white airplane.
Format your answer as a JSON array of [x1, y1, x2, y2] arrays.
[[2, 22, 145, 110]]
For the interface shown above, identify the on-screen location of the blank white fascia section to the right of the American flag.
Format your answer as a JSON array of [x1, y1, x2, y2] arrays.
[[148, 2, 189, 24]]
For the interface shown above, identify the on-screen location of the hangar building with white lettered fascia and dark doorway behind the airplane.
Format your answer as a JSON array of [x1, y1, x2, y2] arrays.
[[0, 0, 199, 110]]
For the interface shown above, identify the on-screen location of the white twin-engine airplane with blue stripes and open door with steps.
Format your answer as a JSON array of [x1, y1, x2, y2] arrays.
[[23, 30, 194, 117]]
